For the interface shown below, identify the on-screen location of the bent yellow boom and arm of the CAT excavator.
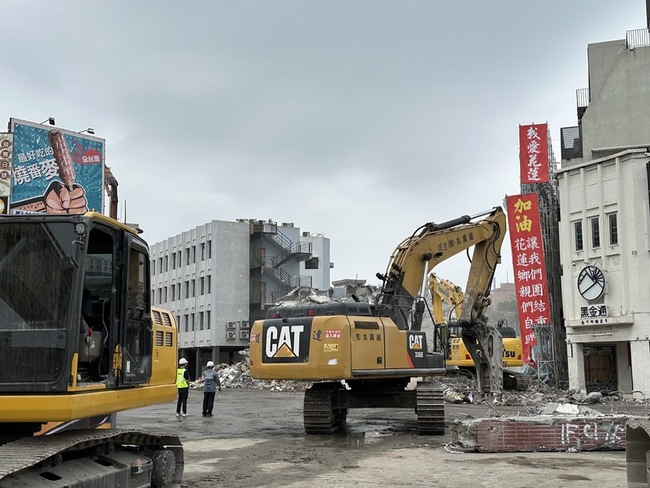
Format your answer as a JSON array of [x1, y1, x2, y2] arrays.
[[377, 207, 506, 393]]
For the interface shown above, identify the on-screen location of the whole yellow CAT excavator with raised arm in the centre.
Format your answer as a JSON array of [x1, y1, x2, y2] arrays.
[[250, 207, 506, 435]]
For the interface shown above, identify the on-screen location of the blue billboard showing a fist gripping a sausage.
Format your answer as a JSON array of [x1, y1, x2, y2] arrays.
[[9, 118, 105, 214]]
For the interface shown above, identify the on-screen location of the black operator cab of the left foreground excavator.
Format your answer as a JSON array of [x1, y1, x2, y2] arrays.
[[0, 211, 152, 393]]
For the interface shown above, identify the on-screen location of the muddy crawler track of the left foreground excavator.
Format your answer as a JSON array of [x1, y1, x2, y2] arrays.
[[0, 429, 183, 488]]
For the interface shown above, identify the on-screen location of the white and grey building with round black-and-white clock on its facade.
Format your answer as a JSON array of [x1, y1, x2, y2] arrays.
[[557, 29, 650, 396]]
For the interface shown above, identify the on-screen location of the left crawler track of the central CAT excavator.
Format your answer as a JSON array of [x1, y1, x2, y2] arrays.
[[303, 383, 348, 434]]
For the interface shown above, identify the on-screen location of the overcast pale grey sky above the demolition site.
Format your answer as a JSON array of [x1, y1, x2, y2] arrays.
[[0, 0, 645, 285]]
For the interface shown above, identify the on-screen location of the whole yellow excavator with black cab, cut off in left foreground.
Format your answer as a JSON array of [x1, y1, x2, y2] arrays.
[[0, 212, 183, 488]]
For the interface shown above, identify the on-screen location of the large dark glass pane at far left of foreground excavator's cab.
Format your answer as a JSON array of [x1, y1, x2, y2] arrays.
[[0, 221, 77, 391]]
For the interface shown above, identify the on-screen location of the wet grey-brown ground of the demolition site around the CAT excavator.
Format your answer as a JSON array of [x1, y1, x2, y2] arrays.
[[117, 389, 647, 488]]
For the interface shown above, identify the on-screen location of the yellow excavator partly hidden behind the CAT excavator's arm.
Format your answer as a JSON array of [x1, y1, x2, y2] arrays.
[[427, 273, 524, 389]]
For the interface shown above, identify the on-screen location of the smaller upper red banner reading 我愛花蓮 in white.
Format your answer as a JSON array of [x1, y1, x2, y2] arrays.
[[519, 124, 548, 185]]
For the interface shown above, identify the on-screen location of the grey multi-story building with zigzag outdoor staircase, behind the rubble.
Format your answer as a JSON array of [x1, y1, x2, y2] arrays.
[[151, 219, 331, 371]]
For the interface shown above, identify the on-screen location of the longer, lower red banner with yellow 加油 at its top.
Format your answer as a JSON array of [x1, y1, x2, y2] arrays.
[[506, 193, 551, 364]]
